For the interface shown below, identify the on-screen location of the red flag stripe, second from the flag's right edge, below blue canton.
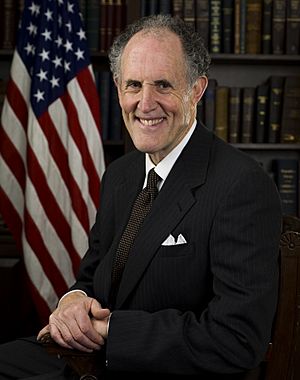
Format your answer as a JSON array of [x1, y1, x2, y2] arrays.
[[61, 93, 100, 207]]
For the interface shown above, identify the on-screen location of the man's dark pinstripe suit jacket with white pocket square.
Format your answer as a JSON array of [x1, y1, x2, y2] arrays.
[[73, 125, 281, 379]]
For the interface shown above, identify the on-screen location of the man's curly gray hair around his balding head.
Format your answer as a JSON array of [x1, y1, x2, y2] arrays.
[[108, 14, 210, 87]]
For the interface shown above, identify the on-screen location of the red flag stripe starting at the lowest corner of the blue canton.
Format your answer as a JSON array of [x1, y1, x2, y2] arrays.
[[39, 112, 90, 233]]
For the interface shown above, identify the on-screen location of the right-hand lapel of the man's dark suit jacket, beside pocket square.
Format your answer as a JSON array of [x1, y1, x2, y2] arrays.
[[116, 126, 212, 308]]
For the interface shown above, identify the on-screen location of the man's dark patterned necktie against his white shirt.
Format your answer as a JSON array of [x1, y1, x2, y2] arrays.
[[109, 169, 161, 305]]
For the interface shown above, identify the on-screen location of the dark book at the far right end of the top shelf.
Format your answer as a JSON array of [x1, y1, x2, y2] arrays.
[[285, 0, 300, 54]]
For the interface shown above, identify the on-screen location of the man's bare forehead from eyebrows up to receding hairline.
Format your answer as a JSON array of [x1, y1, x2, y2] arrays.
[[121, 31, 185, 80]]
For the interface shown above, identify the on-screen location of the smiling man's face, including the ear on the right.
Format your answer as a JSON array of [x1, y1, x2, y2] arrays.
[[117, 32, 207, 164]]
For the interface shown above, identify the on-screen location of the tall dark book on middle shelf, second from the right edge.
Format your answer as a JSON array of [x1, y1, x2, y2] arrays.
[[267, 75, 284, 144]]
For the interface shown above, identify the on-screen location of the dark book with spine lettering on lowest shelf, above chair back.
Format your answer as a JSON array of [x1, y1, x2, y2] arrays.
[[273, 158, 299, 215]]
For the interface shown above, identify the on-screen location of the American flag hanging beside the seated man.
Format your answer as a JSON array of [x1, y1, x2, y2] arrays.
[[0, 0, 104, 321]]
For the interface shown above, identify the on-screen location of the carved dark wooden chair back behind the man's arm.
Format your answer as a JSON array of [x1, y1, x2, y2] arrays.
[[263, 216, 300, 380]]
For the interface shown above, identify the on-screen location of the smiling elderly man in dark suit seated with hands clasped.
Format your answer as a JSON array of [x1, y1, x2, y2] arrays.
[[0, 15, 281, 379]]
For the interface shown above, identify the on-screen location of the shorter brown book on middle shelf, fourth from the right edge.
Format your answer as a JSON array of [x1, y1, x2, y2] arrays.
[[241, 87, 255, 144]]
